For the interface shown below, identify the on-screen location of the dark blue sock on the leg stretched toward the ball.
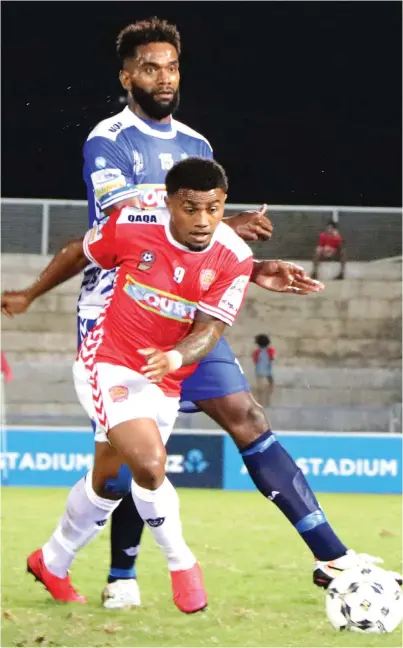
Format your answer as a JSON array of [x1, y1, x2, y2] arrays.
[[241, 430, 347, 560]]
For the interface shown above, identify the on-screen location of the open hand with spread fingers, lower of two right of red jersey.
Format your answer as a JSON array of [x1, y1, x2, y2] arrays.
[[252, 261, 325, 295]]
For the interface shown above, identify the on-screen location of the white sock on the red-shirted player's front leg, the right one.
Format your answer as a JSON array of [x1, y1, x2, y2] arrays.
[[132, 477, 196, 571]]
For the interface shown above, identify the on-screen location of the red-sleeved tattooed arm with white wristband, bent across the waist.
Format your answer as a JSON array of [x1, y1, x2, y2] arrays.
[[139, 256, 253, 383]]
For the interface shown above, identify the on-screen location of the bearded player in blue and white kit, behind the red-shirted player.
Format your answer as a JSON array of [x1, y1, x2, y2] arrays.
[[2, 18, 400, 608]]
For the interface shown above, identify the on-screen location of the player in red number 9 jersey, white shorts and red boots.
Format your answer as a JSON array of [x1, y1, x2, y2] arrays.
[[24, 158, 253, 612]]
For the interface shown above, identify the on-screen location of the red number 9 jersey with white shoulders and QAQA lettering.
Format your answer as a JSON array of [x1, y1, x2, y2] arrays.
[[80, 207, 253, 396]]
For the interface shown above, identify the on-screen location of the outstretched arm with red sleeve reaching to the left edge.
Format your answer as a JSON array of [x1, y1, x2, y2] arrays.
[[1, 211, 120, 317]]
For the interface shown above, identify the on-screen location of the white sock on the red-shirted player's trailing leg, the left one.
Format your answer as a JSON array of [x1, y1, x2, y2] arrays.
[[42, 470, 121, 578]]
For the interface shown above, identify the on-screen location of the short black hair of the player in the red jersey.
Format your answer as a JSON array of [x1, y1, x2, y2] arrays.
[[165, 157, 228, 196]]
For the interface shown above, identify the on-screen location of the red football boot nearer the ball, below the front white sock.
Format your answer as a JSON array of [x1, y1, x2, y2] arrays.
[[170, 563, 207, 614]]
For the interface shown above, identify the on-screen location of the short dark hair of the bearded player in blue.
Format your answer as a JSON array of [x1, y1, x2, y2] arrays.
[[116, 17, 181, 65]]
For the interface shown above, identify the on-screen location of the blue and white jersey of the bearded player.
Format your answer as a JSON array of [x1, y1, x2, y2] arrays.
[[78, 106, 213, 319]]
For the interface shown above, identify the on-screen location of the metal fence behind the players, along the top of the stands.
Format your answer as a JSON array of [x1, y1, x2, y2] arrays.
[[1, 198, 402, 261]]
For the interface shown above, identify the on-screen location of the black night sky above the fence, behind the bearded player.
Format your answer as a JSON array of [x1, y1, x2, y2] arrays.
[[2, 1, 402, 206]]
